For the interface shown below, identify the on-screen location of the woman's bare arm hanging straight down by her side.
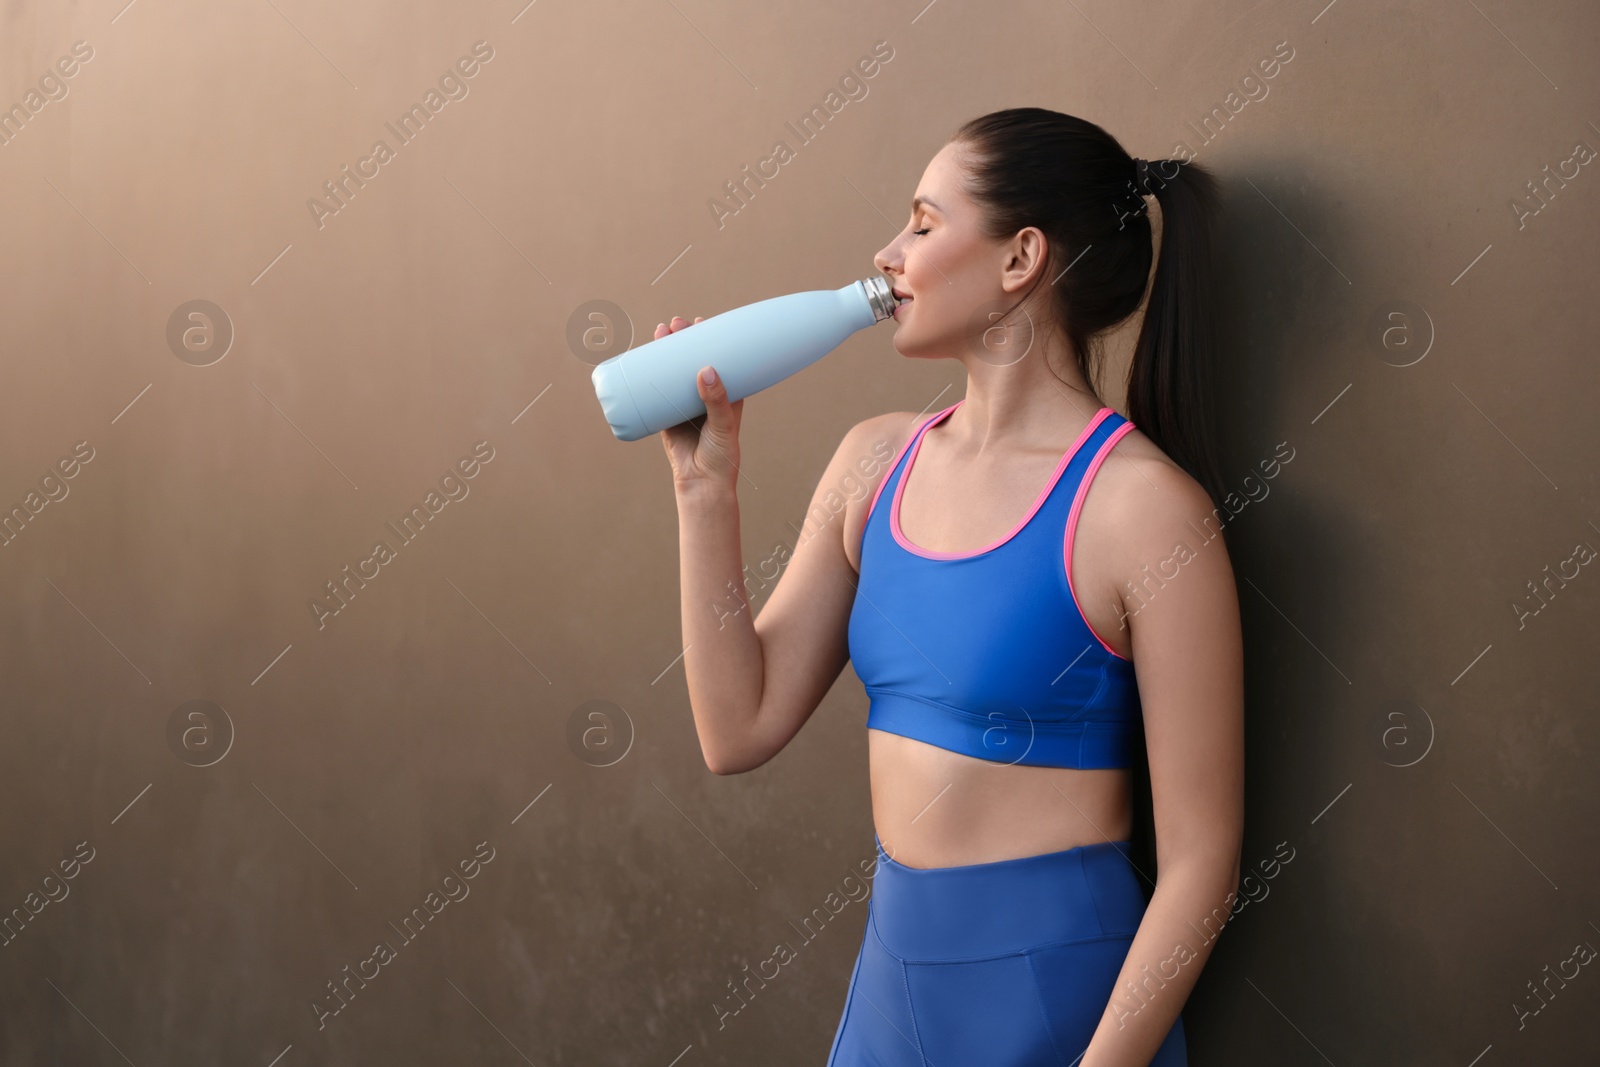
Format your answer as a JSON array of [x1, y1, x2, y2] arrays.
[[1080, 459, 1245, 1067]]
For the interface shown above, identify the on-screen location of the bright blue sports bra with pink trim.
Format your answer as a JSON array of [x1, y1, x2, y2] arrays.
[[848, 400, 1144, 768]]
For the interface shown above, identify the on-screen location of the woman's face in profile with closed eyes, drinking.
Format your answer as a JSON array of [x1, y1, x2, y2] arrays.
[[872, 142, 1016, 357]]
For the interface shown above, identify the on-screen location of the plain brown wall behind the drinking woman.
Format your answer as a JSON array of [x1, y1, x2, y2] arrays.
[[0, 0, 1600, 1067]]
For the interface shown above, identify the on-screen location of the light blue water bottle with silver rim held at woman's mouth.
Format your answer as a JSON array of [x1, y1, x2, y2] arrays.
[[592, 277, 898, 442]]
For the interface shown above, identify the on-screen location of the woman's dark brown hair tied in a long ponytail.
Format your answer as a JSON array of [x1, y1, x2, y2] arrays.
[[950, 107, 1222, 502]]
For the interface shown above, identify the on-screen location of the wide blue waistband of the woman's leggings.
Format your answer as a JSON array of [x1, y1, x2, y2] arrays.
[[869, 835, 1146, 961]]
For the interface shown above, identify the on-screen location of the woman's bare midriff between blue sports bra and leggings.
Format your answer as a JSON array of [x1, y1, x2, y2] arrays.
[[867, 729, 1133, 869]]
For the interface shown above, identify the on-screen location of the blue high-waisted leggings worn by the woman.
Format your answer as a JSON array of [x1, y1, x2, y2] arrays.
[[827, 841, 1189, 1067]]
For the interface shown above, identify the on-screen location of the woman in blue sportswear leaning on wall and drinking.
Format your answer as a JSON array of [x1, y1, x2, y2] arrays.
[[656, 107, 1243, 1067]]
